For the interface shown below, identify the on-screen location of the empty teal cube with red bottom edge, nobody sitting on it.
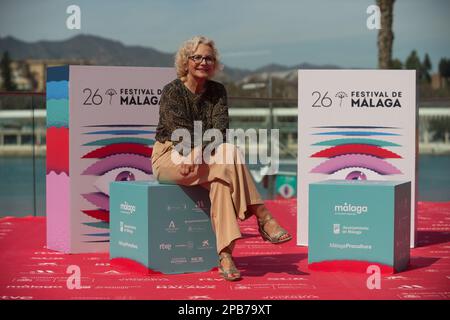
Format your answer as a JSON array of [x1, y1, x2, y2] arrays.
[[308, 180, 411, 273]]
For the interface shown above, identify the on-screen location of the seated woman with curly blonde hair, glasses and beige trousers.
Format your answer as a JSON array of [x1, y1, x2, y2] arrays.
[[152, 36, 292, 281]]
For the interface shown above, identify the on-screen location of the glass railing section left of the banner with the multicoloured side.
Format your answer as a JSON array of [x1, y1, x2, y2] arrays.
[[0, 93, 46, 216]]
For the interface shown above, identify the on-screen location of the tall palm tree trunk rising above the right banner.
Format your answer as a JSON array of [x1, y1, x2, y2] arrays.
[[377, 0, 395, 69]]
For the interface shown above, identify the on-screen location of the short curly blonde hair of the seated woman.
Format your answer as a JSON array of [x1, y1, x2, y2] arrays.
[[175, 36, 222, 82]]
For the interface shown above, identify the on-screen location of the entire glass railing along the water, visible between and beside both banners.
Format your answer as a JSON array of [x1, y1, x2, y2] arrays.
[[0, 93, 450, 217]]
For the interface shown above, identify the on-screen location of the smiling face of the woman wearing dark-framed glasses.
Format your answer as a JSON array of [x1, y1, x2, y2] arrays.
[[188, 43, 216, 79]]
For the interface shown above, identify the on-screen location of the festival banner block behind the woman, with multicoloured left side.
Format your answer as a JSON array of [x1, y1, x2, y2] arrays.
[[46, 65, 176, 253]]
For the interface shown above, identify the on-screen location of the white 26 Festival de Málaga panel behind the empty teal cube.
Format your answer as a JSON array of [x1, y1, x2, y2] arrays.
[[297, 70, 417, 247]]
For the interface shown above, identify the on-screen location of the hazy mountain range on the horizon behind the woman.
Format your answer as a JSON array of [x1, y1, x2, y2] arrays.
[[0, 34, 339, 84]]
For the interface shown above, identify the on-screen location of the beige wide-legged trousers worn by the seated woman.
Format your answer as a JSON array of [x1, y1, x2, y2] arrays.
[[152, 141, 264, 253]]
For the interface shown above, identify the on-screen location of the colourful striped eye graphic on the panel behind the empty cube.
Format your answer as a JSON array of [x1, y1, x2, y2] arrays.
[[310, 126, 402, 180]]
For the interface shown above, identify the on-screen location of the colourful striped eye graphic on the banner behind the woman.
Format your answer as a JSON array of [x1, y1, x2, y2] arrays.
[[81, 125, 155, 242]]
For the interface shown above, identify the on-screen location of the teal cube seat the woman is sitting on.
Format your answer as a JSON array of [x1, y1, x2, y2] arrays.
[[110, 181, 217, 274]]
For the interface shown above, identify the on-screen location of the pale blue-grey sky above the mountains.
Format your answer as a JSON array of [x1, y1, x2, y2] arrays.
[[0, 0, 450, 70]]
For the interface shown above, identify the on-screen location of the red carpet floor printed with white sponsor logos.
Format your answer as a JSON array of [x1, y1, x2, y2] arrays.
[[0, 200, 450, 300]]
